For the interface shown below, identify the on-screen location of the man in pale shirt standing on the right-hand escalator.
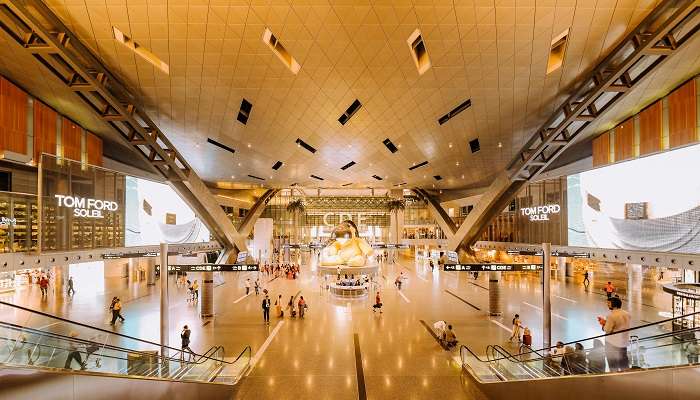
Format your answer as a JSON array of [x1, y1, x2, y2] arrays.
[[598, 297, 631, 372]]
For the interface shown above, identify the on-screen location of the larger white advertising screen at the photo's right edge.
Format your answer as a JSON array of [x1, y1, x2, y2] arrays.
[[567, 145, 700, 253]]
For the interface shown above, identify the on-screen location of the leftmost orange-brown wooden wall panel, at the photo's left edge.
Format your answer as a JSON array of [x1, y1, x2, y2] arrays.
[[0, 77, 27, 154]]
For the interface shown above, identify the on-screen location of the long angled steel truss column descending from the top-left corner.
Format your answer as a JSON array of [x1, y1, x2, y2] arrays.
[[0, 0, 246, 250]]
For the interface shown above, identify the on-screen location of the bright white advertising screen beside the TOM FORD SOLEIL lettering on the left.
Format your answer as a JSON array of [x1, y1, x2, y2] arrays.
[[125, 176, 209, 246]]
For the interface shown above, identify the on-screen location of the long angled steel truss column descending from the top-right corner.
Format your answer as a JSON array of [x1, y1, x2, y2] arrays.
[[448, 0, 700, 250]]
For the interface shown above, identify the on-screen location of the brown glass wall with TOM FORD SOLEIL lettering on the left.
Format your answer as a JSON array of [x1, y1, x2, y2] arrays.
[[41, 155, 126, 251]]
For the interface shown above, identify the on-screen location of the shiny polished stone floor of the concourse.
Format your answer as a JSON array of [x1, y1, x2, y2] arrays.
[[0, 258, 671, 400]]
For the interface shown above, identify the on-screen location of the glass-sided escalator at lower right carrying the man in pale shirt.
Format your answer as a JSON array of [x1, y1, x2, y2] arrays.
[[460, 312, 700, 400]]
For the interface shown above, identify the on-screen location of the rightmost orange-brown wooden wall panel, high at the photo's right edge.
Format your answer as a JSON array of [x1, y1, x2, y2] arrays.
[[668, 79, 697, 148]]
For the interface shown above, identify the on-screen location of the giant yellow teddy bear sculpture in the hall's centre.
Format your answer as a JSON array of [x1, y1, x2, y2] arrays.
[[321, 221, 374, 267]]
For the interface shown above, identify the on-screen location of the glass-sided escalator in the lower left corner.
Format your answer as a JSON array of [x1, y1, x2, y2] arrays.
[[0, 301, 251, 400]]
